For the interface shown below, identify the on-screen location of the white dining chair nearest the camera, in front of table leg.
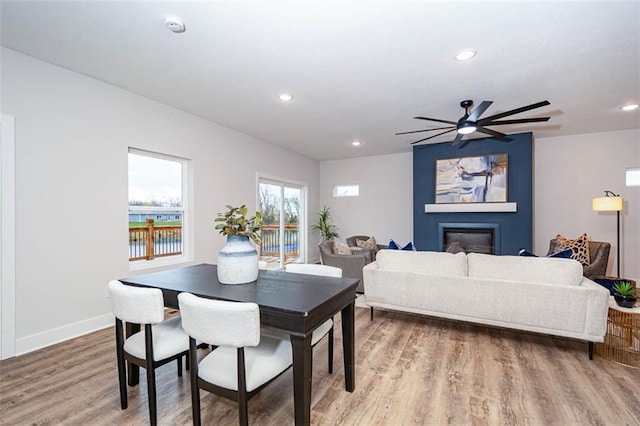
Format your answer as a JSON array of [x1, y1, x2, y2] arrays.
[[178, 293, 293, 425]]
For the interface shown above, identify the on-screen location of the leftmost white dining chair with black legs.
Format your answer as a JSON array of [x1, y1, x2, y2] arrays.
[[107, 280, 189, 425]]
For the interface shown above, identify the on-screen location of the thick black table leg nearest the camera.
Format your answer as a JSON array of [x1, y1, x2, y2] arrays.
[[291, 333, 311, 425]]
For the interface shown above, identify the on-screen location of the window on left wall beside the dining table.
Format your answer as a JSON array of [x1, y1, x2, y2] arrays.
[[128, 149, 188, 266]]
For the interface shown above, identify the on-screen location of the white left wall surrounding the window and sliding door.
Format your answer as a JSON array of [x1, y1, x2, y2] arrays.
[[1, 48, 319, 353]]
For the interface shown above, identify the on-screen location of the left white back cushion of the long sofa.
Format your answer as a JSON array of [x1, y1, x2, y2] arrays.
[[376, 250, 467, 277]]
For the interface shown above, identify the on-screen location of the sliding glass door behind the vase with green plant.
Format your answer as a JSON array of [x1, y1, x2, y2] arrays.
[[258, 179, 305, 269]]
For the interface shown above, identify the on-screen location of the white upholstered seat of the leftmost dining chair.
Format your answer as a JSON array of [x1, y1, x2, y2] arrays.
[[124, 316, 189, 361]]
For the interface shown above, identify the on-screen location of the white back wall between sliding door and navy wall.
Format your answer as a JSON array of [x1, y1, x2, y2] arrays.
[[318, 153, 413, 245]]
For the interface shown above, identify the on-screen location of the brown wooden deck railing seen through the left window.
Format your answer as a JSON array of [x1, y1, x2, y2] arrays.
[[129, 219, 182, 260]]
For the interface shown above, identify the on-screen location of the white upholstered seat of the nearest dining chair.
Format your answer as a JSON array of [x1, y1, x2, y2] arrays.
[[198, 336, 293, 392]]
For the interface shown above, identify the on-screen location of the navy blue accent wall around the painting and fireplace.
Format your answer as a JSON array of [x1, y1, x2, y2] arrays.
[[413, 133, 533, 255]]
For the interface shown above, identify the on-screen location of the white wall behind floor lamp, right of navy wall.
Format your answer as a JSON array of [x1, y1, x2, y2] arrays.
[[534, 129, 640, 282]]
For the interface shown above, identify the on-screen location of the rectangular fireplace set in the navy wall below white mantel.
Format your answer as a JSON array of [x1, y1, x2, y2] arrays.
[[438, 223, 500, 254]]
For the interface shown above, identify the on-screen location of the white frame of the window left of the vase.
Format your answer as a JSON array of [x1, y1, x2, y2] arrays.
[[127, 147, 193, 271]]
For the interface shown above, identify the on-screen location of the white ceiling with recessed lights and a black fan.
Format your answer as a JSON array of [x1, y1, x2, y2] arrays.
[[0, 0, 640, 160]]
